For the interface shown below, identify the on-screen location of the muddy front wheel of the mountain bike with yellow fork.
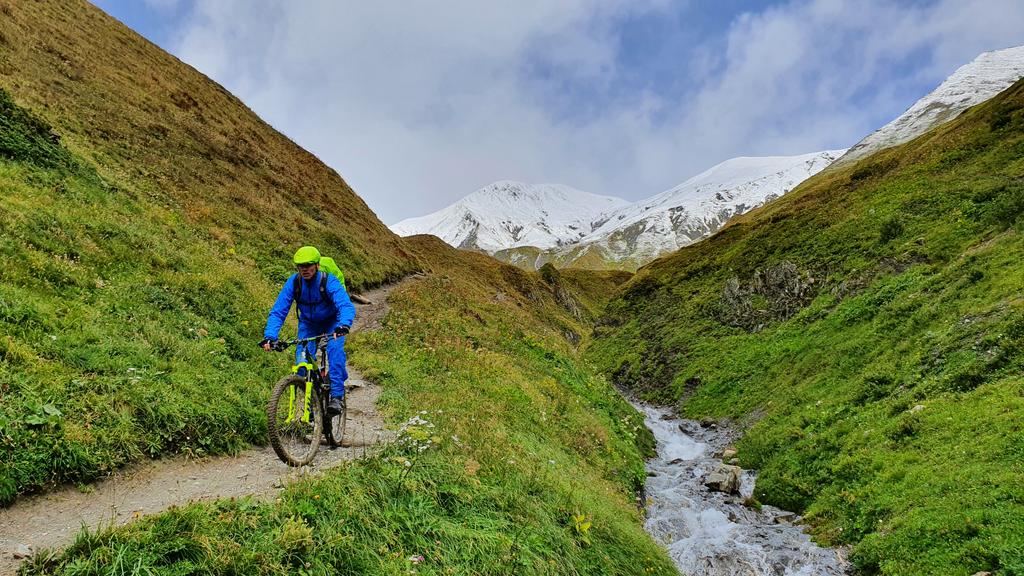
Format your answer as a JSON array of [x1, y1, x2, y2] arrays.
[[266, 374, 324, 466]]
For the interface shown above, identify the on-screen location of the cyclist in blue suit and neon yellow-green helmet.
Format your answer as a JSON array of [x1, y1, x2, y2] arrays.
[[260, 246, 355, 414]]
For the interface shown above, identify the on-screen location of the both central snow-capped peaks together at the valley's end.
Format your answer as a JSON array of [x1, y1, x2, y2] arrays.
[[391, 150, 846, 269]]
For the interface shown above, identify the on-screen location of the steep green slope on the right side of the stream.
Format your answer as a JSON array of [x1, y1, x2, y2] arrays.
[[589, 82, 1024, 575]]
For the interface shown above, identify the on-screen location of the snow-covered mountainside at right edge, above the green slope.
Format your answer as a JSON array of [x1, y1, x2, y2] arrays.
[[836, 46, 1024, 165]]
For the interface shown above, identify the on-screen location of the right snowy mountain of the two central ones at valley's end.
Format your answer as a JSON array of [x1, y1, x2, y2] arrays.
[[551, 150, 846, 268]]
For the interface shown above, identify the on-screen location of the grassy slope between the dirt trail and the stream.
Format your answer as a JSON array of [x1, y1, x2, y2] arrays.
[[27, 237, 675, 575]]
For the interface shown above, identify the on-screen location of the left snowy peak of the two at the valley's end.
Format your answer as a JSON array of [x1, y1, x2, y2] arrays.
[[391, 180, 629, 252]]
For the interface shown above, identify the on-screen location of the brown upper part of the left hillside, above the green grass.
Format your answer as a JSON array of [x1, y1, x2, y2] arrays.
[[0, 0, 415, 287]]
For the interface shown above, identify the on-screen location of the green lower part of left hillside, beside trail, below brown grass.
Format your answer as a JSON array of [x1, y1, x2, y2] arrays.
[[0, 86, 299, 503]]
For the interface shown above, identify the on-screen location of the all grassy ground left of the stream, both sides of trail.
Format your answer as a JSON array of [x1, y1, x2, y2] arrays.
[[0, 0, 674, 575]]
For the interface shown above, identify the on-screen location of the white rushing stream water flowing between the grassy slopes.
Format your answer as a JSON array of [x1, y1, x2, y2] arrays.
[[637, 405, 847, 576]]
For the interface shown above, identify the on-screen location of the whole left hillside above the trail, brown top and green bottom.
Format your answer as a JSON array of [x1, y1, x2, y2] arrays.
[[0, 2, 419, 502]]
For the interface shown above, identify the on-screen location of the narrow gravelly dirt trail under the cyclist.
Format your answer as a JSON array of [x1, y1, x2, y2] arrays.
[[0, 281, 408, 574]]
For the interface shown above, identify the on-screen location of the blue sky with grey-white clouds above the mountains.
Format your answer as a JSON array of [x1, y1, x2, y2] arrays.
[[93, 0, 1024, 223]]
